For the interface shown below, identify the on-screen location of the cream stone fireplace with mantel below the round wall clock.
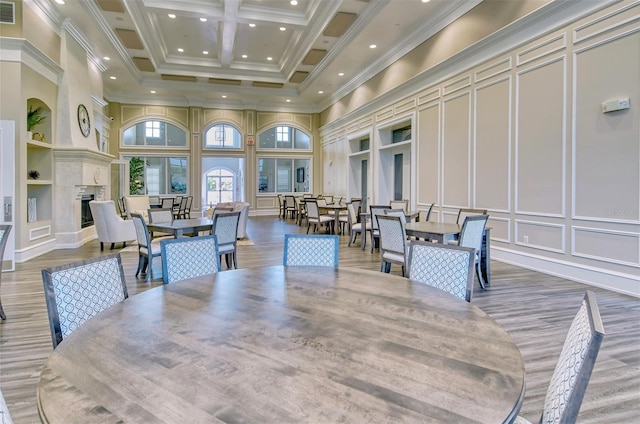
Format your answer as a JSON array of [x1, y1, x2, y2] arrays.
[[53, 147, 114, 248]]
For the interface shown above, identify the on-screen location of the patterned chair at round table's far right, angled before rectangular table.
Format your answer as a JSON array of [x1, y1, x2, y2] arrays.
[[407, 241, 475, 302]]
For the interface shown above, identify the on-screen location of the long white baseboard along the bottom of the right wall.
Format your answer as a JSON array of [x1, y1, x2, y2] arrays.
[[491, 246, 640, 298]]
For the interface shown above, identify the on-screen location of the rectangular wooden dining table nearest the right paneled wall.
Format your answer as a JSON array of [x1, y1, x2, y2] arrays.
[[405, 221, 491, 286]]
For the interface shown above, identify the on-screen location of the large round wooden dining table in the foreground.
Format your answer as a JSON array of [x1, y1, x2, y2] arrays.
[[37, 266, 525, 424]]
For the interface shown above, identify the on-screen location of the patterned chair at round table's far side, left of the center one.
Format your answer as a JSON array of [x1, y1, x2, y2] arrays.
[[160, 235, 220, 284]]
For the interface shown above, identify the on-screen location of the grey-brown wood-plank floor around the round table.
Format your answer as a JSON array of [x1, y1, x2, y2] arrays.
[[0, 217, 640, 424]]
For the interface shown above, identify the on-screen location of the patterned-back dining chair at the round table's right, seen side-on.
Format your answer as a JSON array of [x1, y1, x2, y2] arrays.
[[515, 290, 604, 424]]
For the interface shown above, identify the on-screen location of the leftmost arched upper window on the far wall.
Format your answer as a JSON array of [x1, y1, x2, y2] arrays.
[[122, 119, 187, 147]]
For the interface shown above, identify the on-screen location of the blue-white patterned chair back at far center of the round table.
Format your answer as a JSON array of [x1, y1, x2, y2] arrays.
[[282, 234, 340, 267]]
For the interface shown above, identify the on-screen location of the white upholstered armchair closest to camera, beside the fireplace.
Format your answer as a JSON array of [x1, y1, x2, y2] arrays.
[[89, 200, 136, 250]]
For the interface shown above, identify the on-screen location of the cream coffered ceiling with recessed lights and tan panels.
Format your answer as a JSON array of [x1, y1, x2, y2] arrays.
[[46, 0, 481, 111]]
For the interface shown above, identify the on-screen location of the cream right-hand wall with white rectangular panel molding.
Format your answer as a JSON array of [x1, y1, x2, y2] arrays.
[[321, 1, 640, 296]]
